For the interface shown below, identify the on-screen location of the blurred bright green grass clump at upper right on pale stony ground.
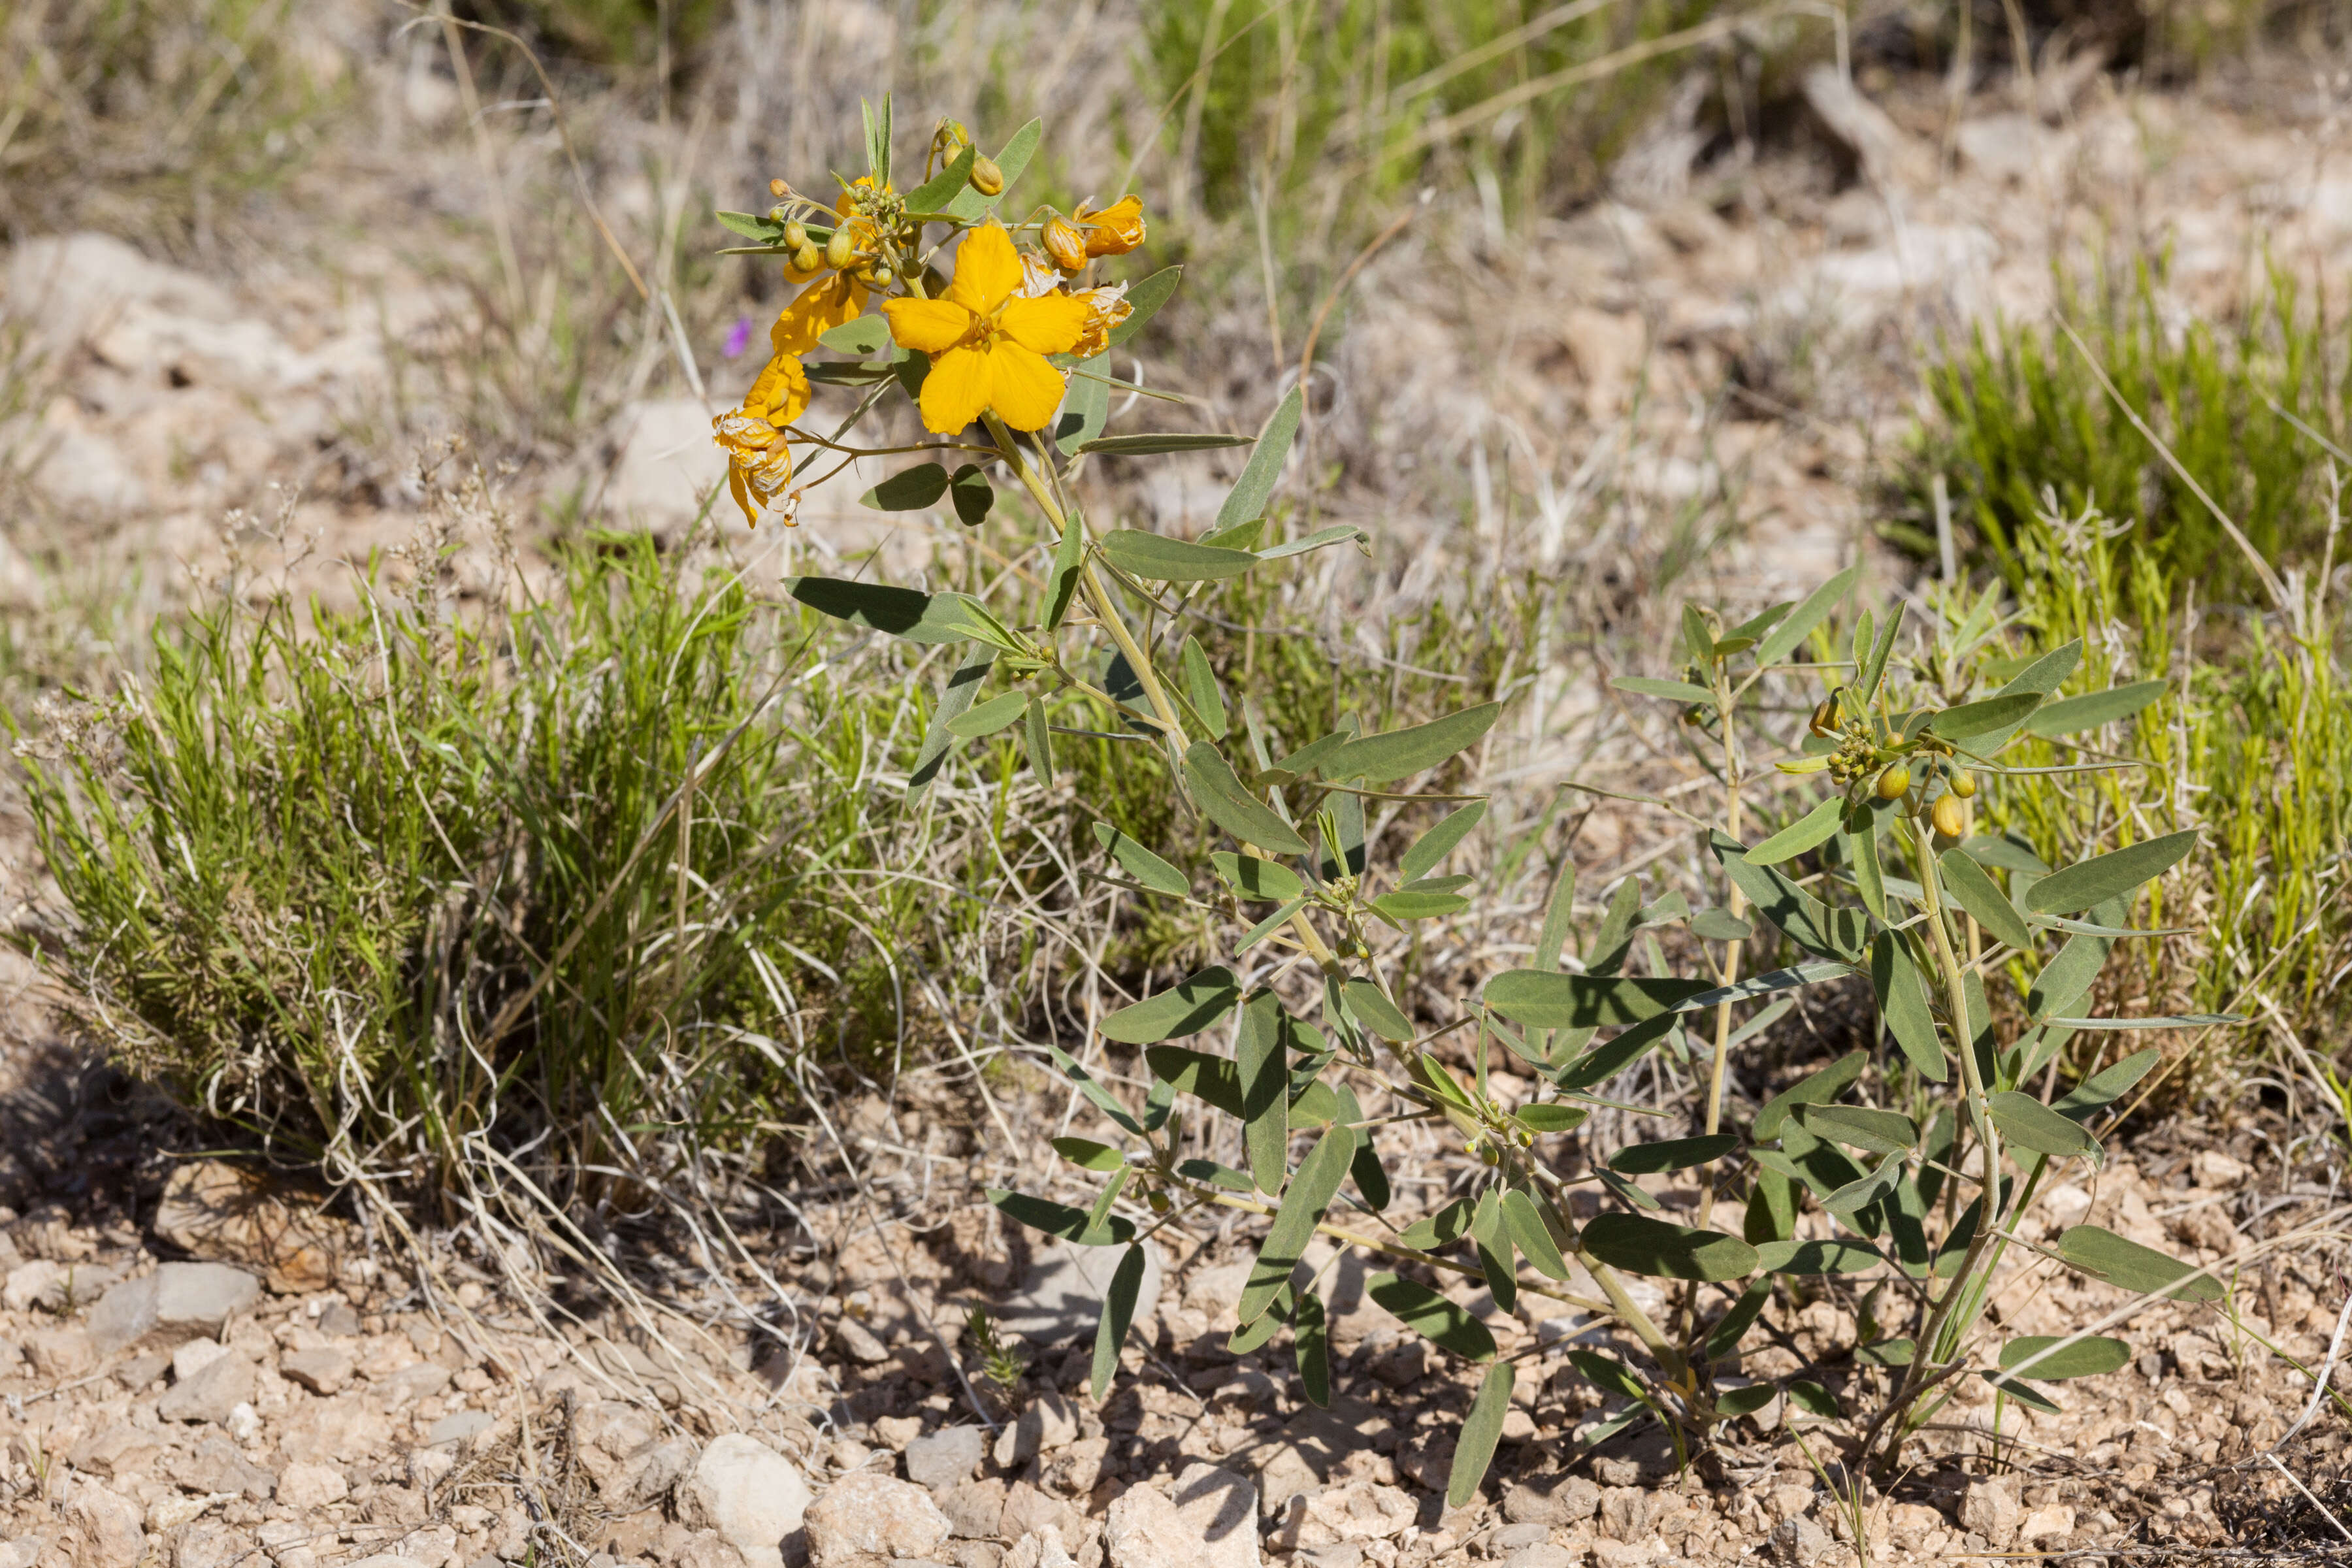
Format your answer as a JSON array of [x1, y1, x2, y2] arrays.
[[1898, 263, 2352, 600]]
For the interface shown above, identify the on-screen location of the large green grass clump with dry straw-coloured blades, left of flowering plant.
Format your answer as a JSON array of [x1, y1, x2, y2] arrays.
[[19, 465, 1028, 1208]]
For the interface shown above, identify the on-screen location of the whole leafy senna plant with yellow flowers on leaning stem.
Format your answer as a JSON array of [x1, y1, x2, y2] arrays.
[[717, 101, 2218, 1505]]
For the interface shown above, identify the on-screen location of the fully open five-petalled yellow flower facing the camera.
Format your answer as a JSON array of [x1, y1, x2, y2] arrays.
[[882, 223, 1089, 435]]
